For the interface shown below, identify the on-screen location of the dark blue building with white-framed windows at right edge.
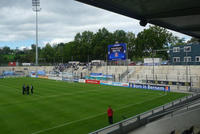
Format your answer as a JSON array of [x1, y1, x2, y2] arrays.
[[169, 44, 200, 65]]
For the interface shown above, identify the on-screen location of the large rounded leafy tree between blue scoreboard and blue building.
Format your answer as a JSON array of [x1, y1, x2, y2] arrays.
[[135, 26, 173, 59]]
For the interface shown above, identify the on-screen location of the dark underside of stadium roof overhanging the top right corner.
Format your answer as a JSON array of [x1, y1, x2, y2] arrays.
[[77, 0, 200, 38]]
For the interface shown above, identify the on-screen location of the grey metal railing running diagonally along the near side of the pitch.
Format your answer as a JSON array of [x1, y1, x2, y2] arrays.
[[89, 94, 200, 134]]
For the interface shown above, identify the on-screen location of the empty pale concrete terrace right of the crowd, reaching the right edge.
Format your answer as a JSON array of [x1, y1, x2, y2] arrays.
[[91, 65, 200, 91]]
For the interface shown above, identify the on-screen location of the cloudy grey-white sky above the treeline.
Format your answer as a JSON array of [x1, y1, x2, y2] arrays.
[[0, 0, 190, 49]]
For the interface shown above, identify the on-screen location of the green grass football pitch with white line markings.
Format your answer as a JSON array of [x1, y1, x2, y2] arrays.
[[0, 78, 186, 134]]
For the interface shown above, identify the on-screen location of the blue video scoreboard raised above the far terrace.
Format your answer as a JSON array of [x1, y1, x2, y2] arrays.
[[108, 43, 126, 61]]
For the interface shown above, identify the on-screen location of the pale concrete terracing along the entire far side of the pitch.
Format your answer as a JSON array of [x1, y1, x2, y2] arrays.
[[0, 65, 200, 91]]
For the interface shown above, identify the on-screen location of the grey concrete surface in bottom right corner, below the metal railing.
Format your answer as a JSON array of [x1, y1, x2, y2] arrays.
[[128, 108, 200, 134]]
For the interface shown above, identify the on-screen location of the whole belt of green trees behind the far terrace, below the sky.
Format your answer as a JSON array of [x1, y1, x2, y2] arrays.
[[0, 26, 186, 63]]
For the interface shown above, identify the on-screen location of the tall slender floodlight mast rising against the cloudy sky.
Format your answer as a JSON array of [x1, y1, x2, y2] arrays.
[[32, 0, 41, 66]]
